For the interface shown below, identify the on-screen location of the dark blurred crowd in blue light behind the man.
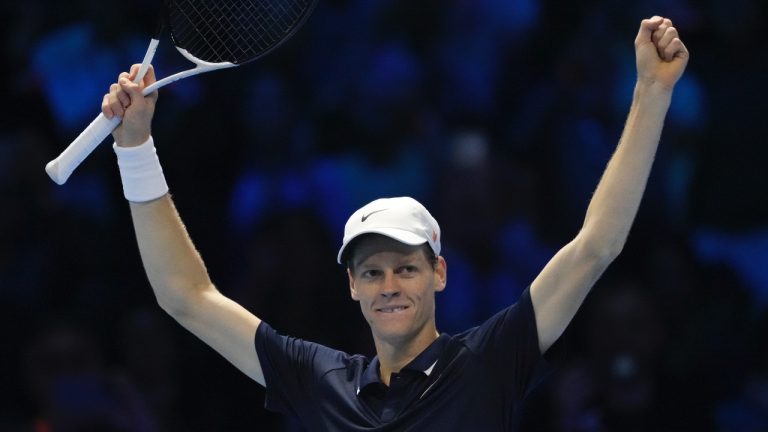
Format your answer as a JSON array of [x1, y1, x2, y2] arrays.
[[0, 0, 768, 432]]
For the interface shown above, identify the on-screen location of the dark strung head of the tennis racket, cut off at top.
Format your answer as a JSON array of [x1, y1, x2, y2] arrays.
[[165, 0, 317, 65]]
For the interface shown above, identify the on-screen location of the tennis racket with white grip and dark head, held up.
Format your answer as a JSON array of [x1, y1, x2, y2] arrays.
[[45, 0, 317, 185]]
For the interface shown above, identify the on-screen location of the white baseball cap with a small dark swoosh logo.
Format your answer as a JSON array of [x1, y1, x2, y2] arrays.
[[336, 197, 440, 264]]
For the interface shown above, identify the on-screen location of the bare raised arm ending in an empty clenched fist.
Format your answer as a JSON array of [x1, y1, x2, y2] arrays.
[[531, 16, 688, 352]]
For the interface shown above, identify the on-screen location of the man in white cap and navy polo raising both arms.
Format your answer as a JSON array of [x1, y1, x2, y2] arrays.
[[102, 17, 688, 431]]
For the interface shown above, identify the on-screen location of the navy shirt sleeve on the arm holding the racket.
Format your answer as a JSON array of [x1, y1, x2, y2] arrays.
[[255, 321, 347, 417]]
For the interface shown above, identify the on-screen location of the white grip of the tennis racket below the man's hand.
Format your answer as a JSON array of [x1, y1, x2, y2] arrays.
[[45, 113, 122, 185]]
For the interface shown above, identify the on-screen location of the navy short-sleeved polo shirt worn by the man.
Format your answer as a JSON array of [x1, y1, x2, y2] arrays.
[[256, 289, 548, 432]]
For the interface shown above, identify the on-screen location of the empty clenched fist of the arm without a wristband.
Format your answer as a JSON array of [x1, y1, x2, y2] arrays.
[[635, 16, 688, 90]]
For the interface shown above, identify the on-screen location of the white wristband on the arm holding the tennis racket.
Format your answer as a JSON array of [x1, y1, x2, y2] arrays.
[[112, 137, 168, 202]]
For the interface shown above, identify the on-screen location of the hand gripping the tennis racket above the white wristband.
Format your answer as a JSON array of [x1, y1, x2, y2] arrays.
[[101, 64, 157, 147]]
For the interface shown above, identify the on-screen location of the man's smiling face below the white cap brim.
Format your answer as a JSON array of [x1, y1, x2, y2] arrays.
[[348, 235, 446, 344]]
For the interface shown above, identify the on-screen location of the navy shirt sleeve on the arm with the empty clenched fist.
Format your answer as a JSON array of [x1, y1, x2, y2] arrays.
[[464, 286, 551, 402]]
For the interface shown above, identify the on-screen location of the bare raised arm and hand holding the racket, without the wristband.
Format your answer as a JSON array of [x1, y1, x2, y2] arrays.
[[102, 65, 264, 385]]
